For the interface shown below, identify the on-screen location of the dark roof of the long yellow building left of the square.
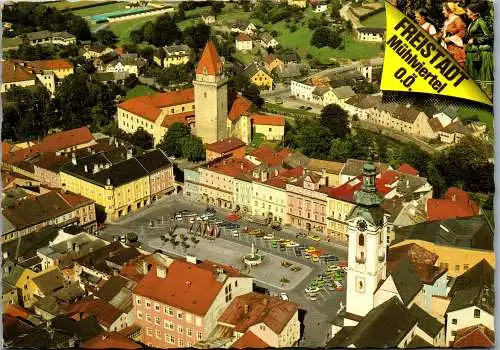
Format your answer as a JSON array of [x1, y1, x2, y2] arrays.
[[61, 152, 148, 187]]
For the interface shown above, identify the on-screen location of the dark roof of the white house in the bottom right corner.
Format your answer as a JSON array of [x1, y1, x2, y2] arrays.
[[446, 286, 495, 315]]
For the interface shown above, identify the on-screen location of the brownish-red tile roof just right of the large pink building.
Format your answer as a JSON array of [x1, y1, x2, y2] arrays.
[[219, 292, 299, 334]]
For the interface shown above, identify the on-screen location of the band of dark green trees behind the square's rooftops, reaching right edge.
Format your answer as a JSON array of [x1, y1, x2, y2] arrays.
[[284, 105, 495, 197]]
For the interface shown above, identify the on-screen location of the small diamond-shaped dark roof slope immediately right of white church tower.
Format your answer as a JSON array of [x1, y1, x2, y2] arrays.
[[391, 257, 422, 305]]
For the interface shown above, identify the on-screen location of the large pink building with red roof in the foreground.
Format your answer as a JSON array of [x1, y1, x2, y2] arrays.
[[133, 257, 252, 349]]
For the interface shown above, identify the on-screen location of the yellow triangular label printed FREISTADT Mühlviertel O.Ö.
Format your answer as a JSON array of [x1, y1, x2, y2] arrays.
[[380, 1, 493, 105]]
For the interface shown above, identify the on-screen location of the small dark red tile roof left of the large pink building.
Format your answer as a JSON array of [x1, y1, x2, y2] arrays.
[[69, 297, 123, 327]]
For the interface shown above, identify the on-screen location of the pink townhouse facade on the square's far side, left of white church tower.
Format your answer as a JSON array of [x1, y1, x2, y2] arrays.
[[286, 172, 328, 236]]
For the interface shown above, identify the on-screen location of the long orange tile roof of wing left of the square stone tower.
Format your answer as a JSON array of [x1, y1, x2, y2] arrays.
[[118, 88, 194, 122]]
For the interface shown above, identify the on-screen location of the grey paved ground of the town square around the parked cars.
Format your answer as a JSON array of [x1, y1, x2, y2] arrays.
[[100, 196, 347, 347]]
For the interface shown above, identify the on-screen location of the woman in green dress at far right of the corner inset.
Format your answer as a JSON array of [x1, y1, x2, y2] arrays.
[[465, 4, 494, 94]]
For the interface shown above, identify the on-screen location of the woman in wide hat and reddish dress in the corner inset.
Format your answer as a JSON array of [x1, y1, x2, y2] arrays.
[[435, 2, 465, 67]]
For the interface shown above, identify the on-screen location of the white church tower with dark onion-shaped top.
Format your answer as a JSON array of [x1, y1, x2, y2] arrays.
[[346, 161, 387, 316]]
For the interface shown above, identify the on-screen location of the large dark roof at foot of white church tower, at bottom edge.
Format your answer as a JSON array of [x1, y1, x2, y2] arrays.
[[339, 296, 417, 348]]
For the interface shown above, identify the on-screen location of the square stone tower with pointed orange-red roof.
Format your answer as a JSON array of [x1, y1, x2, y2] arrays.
[[193, 41, 228, 144]]
